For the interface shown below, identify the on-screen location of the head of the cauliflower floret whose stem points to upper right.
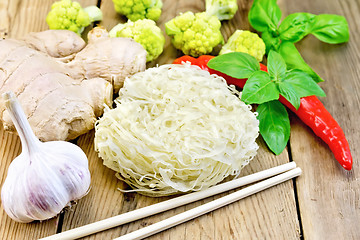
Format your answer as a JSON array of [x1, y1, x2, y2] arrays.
[[165, 11, 224, 57]]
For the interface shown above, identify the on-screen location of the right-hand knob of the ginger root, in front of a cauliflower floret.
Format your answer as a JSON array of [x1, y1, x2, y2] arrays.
[[68, 27, 147, 93]]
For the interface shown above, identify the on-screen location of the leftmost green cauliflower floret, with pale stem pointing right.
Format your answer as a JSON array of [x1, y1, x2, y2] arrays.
[[46, 0, 102, 35]]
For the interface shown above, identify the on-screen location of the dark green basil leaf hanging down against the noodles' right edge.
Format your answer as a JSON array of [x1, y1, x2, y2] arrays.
[[256, 101, 290, 155]]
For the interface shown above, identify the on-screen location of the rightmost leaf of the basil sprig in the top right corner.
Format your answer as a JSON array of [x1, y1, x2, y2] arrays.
[[311, 14, 349, 44]]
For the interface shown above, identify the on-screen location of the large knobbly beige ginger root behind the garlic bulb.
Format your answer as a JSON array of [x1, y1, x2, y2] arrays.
[[0, 28, 146, 141]]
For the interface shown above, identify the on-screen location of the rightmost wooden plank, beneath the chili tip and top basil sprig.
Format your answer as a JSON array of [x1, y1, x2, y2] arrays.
[[283, 0, 360, 239]]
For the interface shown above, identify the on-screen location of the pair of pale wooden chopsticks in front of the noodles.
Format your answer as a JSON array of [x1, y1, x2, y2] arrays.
[[40, 162, 301, 240]]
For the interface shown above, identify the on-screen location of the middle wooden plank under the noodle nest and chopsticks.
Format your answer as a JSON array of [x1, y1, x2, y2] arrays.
[[54, 0, 300, 240]]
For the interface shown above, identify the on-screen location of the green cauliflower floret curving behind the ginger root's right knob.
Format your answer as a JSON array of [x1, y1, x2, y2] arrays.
[[109, 19, 165, 62]]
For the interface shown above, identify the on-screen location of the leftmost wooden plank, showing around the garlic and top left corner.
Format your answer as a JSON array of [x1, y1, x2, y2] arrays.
[[0, 0, 101, 239]]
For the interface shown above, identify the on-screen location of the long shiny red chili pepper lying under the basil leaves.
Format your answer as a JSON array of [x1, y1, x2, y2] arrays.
[[173, 55, 353, 170]]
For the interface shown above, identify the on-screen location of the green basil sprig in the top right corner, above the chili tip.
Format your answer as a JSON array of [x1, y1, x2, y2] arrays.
[[248, 0, 349, 82]]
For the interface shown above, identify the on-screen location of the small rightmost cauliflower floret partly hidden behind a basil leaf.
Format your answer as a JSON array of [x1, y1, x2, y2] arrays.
[[219, 30, 265, 62]]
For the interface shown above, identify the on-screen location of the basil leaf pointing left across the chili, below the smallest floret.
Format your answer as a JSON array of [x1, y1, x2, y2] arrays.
[[207, 52, 260, 78]]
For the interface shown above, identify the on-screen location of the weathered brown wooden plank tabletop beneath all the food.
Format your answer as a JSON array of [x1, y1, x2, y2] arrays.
[[0, 0, 360, 240]]
